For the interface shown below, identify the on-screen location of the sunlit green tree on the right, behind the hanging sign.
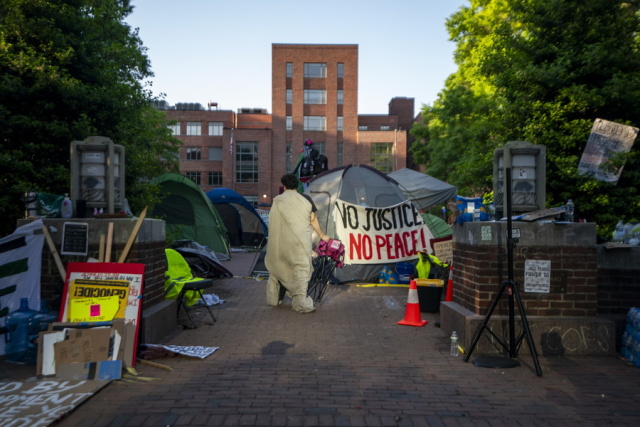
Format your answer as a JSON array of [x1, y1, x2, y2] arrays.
[[411, 0, 640, 235]]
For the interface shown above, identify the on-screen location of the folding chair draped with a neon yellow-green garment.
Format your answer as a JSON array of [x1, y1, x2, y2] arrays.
[[164, 249, 217, 329]]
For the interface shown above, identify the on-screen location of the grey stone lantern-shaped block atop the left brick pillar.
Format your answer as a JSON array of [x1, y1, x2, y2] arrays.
[[70, 136, 125, 214]]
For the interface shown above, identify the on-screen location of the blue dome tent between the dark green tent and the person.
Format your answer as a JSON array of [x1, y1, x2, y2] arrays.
[[206, 187, 268, 247]]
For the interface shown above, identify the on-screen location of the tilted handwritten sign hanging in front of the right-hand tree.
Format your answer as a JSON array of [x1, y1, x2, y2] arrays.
[[578, 119, 638, 185]]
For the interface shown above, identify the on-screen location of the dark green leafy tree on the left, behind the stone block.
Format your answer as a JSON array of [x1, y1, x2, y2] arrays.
[[0, 0, 179, 235]]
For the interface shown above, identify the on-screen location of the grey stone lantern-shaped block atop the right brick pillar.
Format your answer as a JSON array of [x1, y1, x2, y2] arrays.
[[493, 141, 547, 216]]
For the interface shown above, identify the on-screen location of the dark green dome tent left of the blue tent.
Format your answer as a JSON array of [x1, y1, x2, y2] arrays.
[[151, 173, 229, 260]]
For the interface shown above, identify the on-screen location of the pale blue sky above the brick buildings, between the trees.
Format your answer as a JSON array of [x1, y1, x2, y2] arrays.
[[126, 0, 469, 114]]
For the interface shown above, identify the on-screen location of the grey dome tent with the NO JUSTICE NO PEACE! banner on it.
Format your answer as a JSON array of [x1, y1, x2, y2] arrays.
[[305, 165, 433, 282]]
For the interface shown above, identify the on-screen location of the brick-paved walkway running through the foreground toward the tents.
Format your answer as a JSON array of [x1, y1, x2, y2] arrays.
[[3, 253, 640, 427]]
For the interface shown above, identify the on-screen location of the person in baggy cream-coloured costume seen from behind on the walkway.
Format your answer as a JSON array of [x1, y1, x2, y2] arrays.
[[265, 174, 330, 313]]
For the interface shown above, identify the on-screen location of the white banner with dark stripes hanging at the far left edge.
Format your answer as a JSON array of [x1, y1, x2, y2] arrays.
[[0, 219, 44, 355]]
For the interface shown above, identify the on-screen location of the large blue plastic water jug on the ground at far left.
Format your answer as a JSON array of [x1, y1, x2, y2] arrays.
[[5, 298, 37, 364]]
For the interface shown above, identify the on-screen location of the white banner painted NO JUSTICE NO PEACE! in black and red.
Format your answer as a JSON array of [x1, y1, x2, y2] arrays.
[[333, 200, 433, 264]]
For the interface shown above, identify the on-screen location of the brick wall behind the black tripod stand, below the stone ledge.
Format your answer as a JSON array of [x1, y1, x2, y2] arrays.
[[453, 222, 598, 317]]
